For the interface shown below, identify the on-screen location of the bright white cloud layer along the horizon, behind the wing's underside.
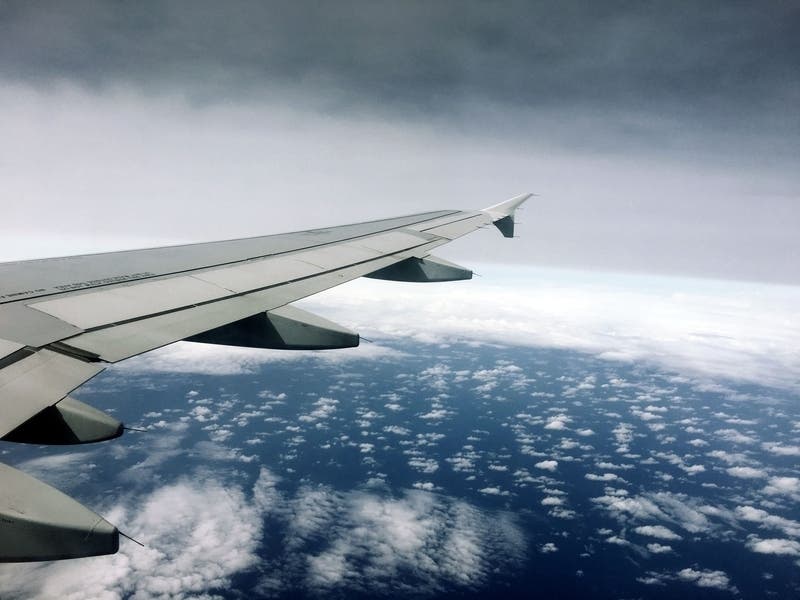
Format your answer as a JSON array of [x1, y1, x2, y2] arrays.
[[115, 266, 800, 391]]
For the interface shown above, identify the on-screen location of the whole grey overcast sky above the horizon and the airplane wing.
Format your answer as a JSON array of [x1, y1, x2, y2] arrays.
[[0, 1, 800, 284]]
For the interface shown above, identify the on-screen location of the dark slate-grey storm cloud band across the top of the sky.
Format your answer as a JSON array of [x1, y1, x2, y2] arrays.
[[0, 1, 800, 131]]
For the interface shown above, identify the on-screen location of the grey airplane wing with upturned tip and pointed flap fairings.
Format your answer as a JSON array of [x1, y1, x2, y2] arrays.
[[0, 194, 530, 562]]
